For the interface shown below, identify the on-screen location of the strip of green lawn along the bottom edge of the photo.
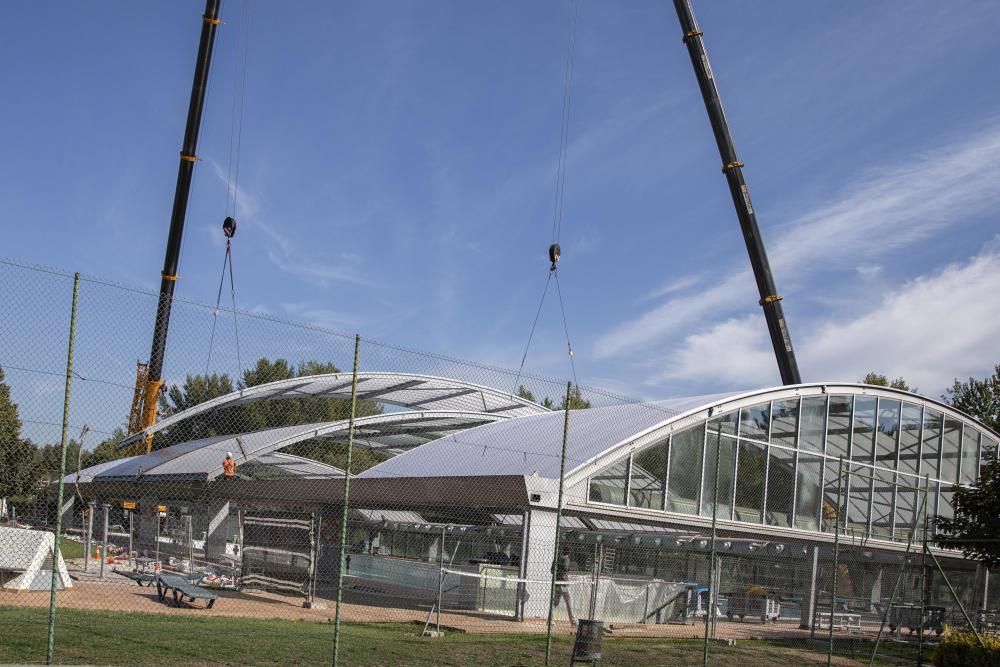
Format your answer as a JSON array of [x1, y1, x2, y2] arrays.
[[0, 607, 908, 667]]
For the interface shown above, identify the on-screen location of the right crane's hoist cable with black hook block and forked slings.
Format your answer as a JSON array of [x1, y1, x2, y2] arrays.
[[514, 0, 580, 393]]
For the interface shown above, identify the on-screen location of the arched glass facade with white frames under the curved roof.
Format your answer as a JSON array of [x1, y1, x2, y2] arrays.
[[589, 394, 998, 541]]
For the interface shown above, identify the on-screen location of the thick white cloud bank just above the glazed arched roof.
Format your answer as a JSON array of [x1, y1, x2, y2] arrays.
[[655, 237, 1000, 396]]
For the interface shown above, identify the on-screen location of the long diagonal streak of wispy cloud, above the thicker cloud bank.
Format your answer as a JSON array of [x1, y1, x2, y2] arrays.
[[595, 123, 1000, 357]]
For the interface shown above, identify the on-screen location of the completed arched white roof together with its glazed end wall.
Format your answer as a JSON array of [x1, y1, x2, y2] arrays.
[[359, 383, 1000, 542]]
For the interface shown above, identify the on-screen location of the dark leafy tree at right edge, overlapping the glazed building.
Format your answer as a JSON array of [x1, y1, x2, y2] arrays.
[[936, 459, 1000, 568]]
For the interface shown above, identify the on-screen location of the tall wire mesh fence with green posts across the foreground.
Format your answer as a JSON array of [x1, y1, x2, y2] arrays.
[[0, 261, 998, 665]]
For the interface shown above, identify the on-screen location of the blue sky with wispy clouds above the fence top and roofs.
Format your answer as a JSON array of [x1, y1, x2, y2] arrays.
[[0, 0, 1000, 420]]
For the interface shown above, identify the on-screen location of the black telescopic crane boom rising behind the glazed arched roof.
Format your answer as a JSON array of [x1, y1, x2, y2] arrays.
[[674, 0, 802, 385]]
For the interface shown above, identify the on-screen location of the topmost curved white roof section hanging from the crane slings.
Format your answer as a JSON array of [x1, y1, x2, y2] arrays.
[[119, 372, 550, 447]]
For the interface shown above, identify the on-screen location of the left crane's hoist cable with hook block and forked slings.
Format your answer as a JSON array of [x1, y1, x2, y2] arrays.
[[205, 0, 253, 377]]
